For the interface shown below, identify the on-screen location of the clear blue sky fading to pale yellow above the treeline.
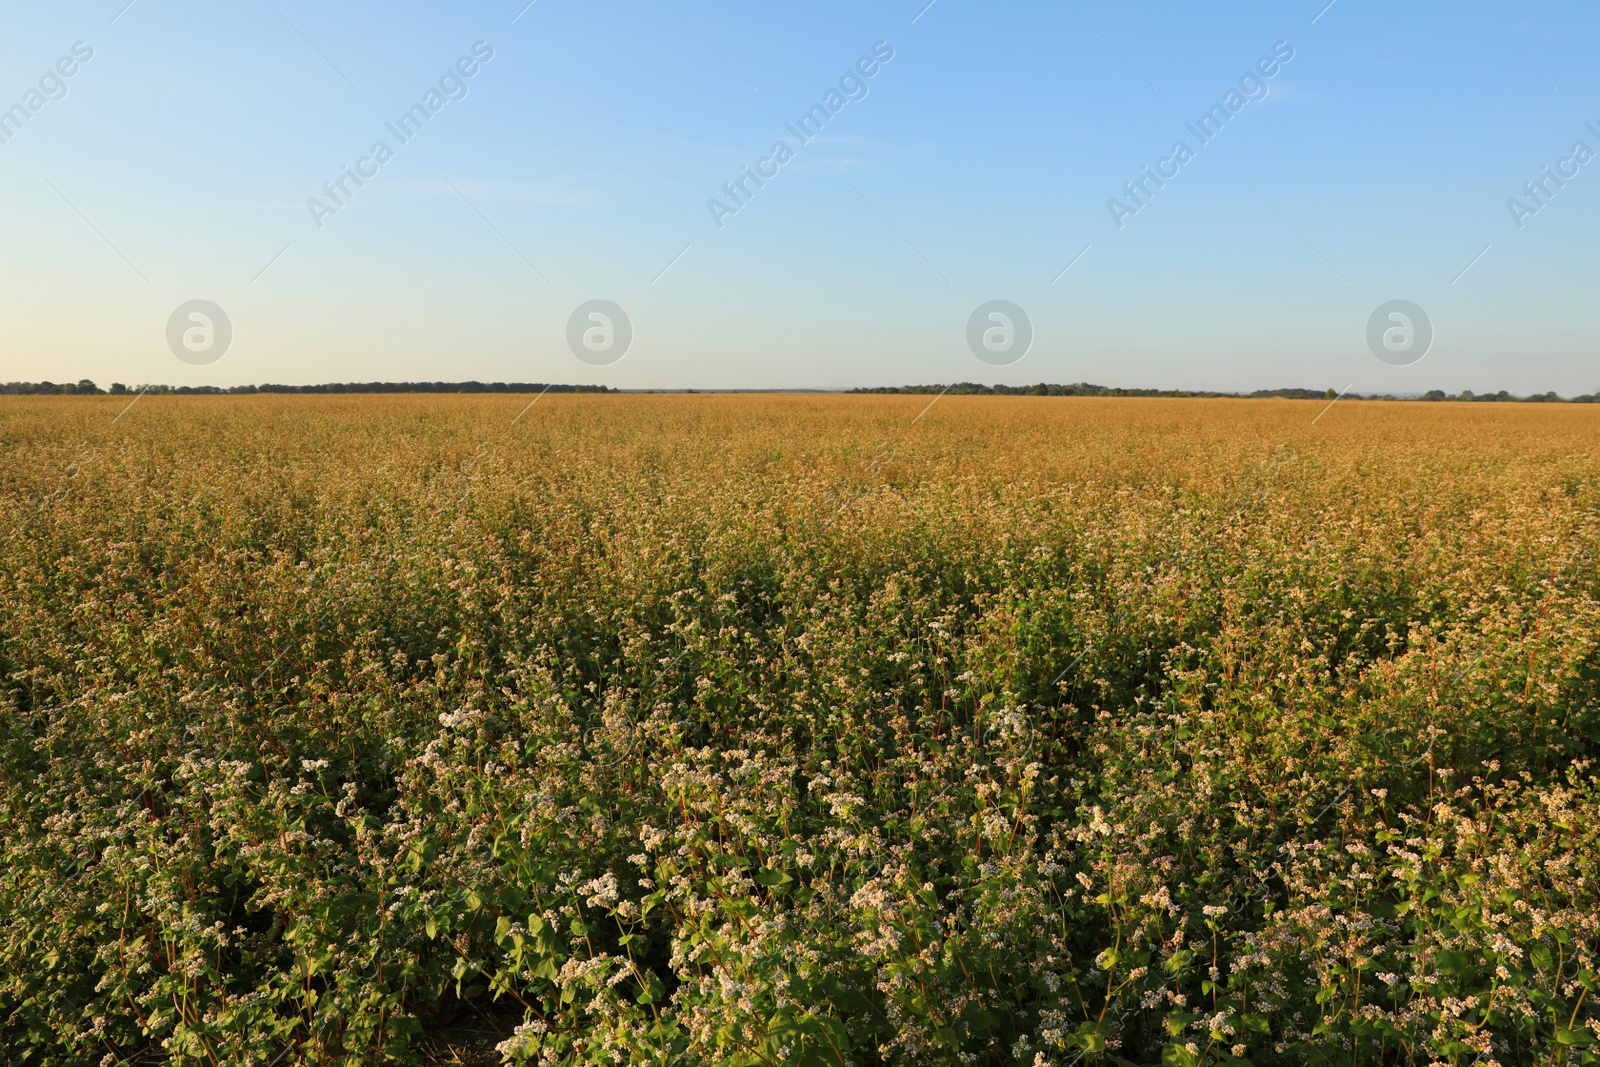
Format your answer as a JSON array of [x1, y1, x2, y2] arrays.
[[0, 0, 1600, 395]]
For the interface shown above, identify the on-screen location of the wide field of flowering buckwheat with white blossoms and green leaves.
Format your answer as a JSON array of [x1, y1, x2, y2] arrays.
[[0, 395, 1600, 1067]]
